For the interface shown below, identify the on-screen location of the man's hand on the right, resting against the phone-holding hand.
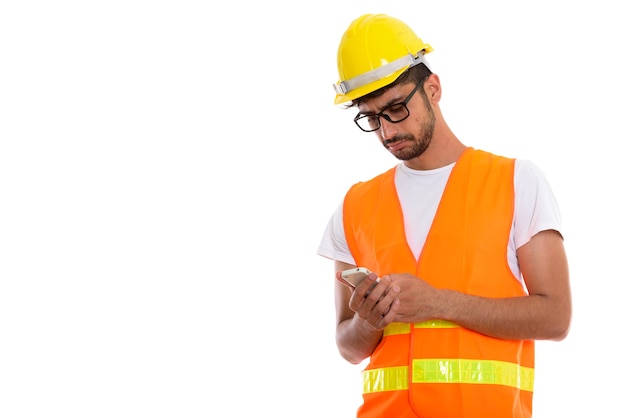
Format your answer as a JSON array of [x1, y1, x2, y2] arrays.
[[383, 273, 439, 322]]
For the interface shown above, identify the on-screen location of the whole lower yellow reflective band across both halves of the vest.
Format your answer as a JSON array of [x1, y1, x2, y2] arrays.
[[363, 359, 535, 394]]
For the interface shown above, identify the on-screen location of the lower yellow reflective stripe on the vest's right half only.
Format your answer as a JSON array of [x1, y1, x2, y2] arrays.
[[412, 359, 535, 391]]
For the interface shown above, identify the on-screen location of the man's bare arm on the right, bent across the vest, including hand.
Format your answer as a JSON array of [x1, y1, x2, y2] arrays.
[[391, 230, 572, 341]]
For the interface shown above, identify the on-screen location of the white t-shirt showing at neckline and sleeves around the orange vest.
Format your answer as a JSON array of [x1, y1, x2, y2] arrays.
[[317, 160, 562, 282]]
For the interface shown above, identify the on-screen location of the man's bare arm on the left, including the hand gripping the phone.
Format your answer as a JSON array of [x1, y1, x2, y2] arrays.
[[335, 261, 400, 364]]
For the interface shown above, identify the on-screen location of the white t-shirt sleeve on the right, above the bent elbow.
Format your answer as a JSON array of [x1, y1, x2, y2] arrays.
[[513, 160, 563, 249]]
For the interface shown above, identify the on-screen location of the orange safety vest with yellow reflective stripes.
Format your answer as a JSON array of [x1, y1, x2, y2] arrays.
[[343, 148, 535, 418]]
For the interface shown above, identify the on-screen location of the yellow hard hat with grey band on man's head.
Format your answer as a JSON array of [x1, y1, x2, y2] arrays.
[[334, 14, 433, 105]]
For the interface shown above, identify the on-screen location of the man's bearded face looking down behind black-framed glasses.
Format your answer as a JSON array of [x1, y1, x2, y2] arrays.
[[359, 84, 436, 161]]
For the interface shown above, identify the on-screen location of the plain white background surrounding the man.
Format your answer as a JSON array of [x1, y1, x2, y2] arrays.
[[0, 0, 626, 418]]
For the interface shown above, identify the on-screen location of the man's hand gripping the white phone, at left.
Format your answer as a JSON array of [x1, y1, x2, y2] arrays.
[[349, 273, 400, 331]]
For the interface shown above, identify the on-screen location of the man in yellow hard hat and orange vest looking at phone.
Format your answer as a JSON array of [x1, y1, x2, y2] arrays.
[[318, 15, 572, 418]]
